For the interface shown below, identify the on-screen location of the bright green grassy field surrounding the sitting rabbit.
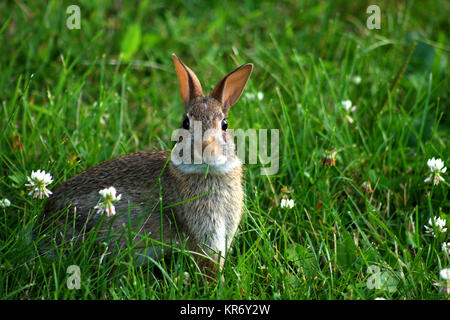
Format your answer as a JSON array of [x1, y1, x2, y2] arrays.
[[0, 0, 450, 299]]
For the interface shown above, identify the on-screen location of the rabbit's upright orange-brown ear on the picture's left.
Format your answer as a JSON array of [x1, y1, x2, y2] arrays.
[[172, 54, 204, 106]]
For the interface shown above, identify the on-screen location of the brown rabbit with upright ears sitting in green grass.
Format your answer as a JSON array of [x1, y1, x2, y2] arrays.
[[43, 54, 253, 277]]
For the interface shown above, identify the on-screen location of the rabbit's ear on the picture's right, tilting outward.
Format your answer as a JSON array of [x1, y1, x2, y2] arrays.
[[210, 63, 253, 113]]
